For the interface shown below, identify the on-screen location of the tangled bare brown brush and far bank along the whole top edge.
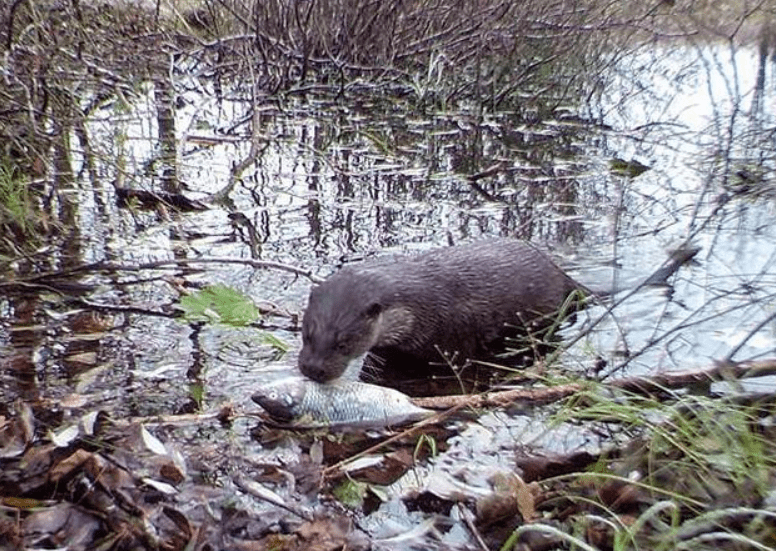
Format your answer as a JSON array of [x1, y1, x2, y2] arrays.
[[0, 0, 773, 250]]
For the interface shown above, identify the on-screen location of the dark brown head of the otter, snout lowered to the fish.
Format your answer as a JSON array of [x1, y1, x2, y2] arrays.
[[299, 274, 383, 382]]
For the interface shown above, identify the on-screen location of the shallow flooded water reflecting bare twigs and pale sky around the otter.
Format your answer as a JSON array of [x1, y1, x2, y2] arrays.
[[0, 14, 776, 543]]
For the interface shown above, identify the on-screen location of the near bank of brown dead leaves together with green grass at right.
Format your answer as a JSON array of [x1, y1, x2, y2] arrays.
[[0, 361, 776, 551]]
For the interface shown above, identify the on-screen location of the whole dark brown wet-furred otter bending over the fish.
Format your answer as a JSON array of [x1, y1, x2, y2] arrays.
[[299, 238, 586, 382]]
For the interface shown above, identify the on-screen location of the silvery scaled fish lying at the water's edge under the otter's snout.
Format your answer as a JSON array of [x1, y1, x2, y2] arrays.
[[251, 376, 434, 429]]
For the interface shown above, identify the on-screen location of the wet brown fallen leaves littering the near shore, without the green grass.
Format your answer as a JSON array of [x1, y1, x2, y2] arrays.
[[6, 360, 768, 551]]
